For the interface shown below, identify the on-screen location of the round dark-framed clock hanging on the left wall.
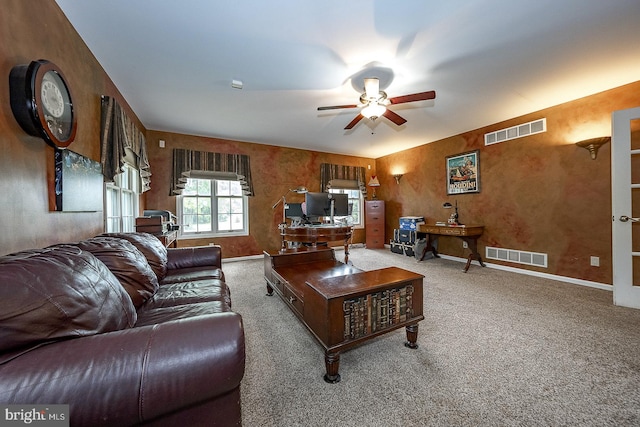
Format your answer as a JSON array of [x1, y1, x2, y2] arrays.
[[9, 59, 77, 148]]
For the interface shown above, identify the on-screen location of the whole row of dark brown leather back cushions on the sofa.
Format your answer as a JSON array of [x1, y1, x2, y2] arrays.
[[0, 233, 167, 363]]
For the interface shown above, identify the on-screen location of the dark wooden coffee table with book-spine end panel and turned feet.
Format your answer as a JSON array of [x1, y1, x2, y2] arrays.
[[264, 249, 424, 383]]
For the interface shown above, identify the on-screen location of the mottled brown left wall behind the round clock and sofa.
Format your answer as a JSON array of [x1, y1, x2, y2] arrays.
[[0, 0, 142, 254]]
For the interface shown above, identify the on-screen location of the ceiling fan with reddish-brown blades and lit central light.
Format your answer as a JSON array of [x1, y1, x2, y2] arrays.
[[318, 77, 436, 129]]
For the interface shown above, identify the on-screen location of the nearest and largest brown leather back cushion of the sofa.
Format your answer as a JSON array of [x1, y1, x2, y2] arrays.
[[0, 245, 137, 351]]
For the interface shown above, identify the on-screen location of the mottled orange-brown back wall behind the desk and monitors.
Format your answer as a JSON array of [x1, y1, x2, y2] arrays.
[[145, 131, 375, 258]]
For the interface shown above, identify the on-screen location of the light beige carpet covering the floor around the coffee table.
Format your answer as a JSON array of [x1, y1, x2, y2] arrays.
[[223, 248, 640, 427]]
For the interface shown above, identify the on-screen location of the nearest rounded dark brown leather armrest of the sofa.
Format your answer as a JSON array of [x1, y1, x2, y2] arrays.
[[0, 312, 245, 426]]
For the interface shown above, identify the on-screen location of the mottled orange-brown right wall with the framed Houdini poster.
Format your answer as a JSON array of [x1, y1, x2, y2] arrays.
[[376, 82, 640, 283]]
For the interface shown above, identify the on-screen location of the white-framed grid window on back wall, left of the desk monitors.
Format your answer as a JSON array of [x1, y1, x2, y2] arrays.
[[176, 178, 249, 238]]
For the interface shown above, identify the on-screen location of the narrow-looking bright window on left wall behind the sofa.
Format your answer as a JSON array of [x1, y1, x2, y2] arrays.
[[104, 163, 140, 233]]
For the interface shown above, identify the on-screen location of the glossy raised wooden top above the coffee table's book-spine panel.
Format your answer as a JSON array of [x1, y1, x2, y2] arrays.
[[307, 267, 424, 299]]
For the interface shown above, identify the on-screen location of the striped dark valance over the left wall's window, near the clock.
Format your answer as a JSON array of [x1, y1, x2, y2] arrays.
[[100, 96, 151, 193]]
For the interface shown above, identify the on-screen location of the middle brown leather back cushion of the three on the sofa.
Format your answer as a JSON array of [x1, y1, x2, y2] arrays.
[[76, 236, 158, 307]]
